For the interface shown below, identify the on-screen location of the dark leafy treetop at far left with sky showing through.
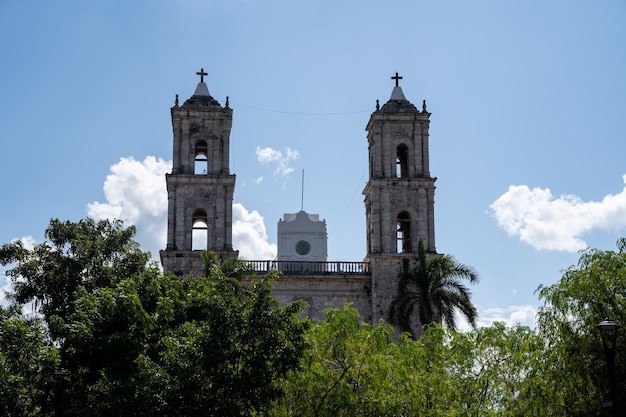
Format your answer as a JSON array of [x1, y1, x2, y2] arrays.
[[0, 219, 150, 339]]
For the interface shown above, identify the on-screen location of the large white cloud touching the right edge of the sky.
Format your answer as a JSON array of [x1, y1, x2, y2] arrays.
[[490, 175, 626, 252]]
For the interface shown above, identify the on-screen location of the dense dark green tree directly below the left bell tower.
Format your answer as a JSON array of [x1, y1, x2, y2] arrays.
[[62, 269, 308, 417]]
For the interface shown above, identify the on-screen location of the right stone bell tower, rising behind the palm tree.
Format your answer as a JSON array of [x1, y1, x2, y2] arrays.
[[363, 73, 436, 322]]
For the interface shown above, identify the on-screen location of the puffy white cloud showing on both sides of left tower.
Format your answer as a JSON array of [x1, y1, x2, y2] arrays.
[[87, 156, 276, 260]]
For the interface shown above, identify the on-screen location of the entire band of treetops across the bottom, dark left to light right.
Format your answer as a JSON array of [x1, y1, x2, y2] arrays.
[[0, 219, 626, 417]]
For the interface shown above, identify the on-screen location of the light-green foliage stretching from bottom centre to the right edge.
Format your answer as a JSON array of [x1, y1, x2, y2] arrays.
[[272, 239, 626, 417]]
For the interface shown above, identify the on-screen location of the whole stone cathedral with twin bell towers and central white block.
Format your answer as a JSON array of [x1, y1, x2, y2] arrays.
[[160, 70, 436, 323]]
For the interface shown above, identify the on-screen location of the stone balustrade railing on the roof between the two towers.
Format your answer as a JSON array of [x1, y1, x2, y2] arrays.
[[245, 261, 370, 275]]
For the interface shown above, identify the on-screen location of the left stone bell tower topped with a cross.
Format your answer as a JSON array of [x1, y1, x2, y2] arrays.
[[160, 69, 238, 275]]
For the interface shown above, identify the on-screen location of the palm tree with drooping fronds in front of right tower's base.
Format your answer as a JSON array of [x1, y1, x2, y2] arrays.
[[389, 239, 478, 339]]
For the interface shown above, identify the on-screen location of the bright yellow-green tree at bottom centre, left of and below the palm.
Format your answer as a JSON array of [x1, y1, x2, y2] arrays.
[[272, 307, 425, 417]]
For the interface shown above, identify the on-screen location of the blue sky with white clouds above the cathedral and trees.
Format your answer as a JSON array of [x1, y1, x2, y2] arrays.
[[0, 0, 626, 324]]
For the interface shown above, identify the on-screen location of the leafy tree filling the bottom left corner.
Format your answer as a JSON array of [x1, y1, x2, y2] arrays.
[[0, 305, 59, 417]]
